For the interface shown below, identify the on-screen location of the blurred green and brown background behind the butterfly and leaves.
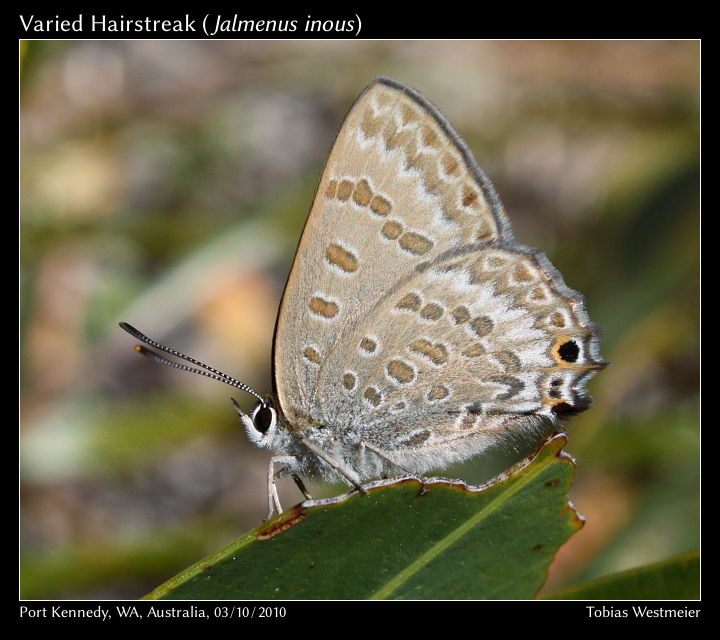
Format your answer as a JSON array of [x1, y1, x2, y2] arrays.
[[20, 41, 699, 599]]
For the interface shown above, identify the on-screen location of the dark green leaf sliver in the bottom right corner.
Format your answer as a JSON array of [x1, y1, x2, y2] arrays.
[[545, 551, 700, 600]]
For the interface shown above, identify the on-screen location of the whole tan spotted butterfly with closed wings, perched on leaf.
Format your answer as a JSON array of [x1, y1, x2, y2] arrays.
[[121, 77, 606, 517]]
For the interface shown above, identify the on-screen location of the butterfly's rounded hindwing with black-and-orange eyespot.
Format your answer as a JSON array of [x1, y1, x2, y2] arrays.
[[313, 244, 600, 457]]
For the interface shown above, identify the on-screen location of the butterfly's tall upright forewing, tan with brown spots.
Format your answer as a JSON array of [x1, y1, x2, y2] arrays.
[[274, 80, 504, 421]]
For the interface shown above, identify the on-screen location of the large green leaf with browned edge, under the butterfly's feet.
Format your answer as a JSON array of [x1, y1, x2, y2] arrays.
[[146, 434, 583, 600]]
